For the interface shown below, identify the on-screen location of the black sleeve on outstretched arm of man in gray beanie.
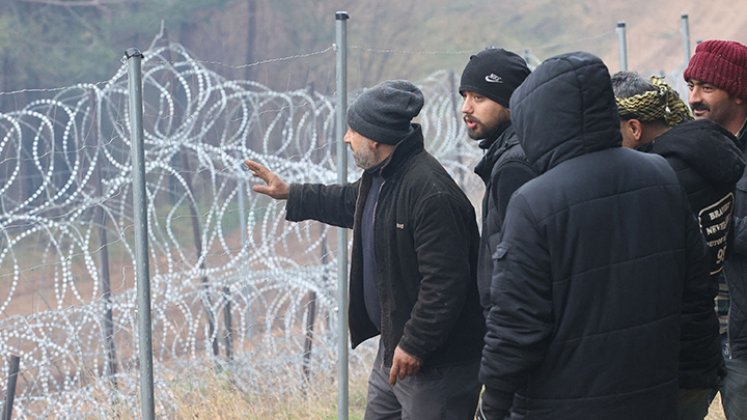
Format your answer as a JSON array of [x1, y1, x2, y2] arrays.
[[285, 180, 360, 228]]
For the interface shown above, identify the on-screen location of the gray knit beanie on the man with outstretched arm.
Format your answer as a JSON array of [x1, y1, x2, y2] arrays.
[[348, 80, 423, 144]]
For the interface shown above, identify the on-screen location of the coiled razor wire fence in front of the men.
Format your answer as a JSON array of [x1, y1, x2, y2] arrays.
[[0, 44, 482, 418]]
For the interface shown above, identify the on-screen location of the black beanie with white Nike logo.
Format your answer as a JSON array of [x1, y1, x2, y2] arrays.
[[459, 48, 529, 108]]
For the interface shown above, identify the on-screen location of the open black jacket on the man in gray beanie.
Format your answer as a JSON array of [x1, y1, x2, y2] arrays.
[[286, 125, 485, 367]]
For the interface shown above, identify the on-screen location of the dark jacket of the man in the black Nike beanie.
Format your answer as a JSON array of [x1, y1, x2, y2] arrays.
[[475, 125, 537, 312]]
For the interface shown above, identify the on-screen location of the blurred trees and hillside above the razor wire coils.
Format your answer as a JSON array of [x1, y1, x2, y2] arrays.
[[0, 0, 747, 111]]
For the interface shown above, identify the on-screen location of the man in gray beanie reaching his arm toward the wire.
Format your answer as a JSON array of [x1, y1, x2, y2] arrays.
[[246, 80, 485, 419]]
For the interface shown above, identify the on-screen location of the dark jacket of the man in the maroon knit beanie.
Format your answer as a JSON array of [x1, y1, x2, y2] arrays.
[[724, 127, 747, 359]]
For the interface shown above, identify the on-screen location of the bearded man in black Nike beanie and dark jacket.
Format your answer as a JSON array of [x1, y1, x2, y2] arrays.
[[459, 48, 537, 313]]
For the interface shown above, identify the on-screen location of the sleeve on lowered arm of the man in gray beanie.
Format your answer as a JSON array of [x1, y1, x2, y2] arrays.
[[399, 193, 478, 360]]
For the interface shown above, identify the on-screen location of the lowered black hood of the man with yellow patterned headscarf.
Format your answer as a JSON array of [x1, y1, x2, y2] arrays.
[[653, 119, 745, 185]]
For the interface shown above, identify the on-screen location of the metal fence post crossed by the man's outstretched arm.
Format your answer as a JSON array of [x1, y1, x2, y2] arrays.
[[335, 11, 349, 420]]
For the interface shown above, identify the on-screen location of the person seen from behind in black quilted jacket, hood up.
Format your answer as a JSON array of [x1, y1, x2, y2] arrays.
[[480, 52, 716, 420]]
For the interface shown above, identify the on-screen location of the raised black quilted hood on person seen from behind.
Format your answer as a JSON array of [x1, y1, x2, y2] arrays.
[[510, 52, 622, 173]]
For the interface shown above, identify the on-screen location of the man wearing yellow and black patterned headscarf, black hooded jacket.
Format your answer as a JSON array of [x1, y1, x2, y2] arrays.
[[612, 72, 745, 420]]
